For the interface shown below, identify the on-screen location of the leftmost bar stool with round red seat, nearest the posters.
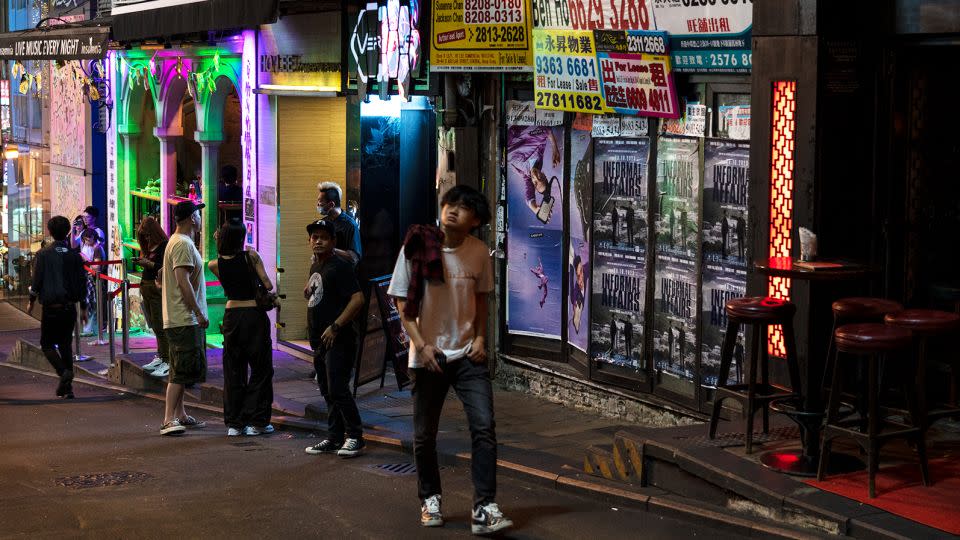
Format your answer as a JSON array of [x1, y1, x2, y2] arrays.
[[710, 296, 801, 454]]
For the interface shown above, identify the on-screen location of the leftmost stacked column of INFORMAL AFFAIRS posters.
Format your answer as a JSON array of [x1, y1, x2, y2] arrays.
[[591, 138, 650, 371]]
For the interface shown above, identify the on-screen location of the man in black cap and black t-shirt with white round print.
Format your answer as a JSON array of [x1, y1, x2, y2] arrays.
[[304, 219, 365, 458]]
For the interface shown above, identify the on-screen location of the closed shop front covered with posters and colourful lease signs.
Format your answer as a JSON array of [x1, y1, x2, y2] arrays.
[[499, 1, 753, 410]]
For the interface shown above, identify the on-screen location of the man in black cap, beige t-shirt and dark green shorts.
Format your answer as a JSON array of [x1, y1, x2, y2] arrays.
[[160, 201, 210, 435]]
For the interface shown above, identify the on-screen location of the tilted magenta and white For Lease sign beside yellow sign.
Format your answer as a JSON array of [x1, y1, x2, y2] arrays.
[[595, 30, 679, 118]]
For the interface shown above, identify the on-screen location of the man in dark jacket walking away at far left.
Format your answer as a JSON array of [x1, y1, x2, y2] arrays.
[[27, 216, 87, 399]]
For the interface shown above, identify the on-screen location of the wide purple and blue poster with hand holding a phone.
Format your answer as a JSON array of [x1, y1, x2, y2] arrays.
[[507, 125, 564, 339]]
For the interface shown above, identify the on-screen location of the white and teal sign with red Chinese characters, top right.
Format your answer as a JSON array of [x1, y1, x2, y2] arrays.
[[649, 0, 753, 73]]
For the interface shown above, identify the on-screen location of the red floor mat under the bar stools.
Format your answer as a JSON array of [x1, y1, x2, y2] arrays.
[[807, 458, 960, 535]]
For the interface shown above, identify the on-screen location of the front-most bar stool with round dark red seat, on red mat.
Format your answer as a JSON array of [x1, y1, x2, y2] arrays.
[[817, 323, 929, 498]]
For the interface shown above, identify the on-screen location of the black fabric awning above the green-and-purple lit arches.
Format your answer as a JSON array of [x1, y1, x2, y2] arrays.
[[111, 0, 279, 41]]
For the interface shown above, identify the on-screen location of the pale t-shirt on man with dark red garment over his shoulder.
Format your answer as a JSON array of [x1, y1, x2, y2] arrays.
[[387, 236, 493, 368]]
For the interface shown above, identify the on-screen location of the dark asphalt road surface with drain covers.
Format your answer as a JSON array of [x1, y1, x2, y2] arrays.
[[0, 366, 736, 540]]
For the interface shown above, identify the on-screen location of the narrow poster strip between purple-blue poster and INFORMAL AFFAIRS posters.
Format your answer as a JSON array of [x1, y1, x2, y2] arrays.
[[567, 129, 593, 353]]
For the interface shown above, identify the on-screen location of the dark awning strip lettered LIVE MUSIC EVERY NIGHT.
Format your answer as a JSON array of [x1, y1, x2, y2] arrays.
[[0, 26, 110, 61]]
